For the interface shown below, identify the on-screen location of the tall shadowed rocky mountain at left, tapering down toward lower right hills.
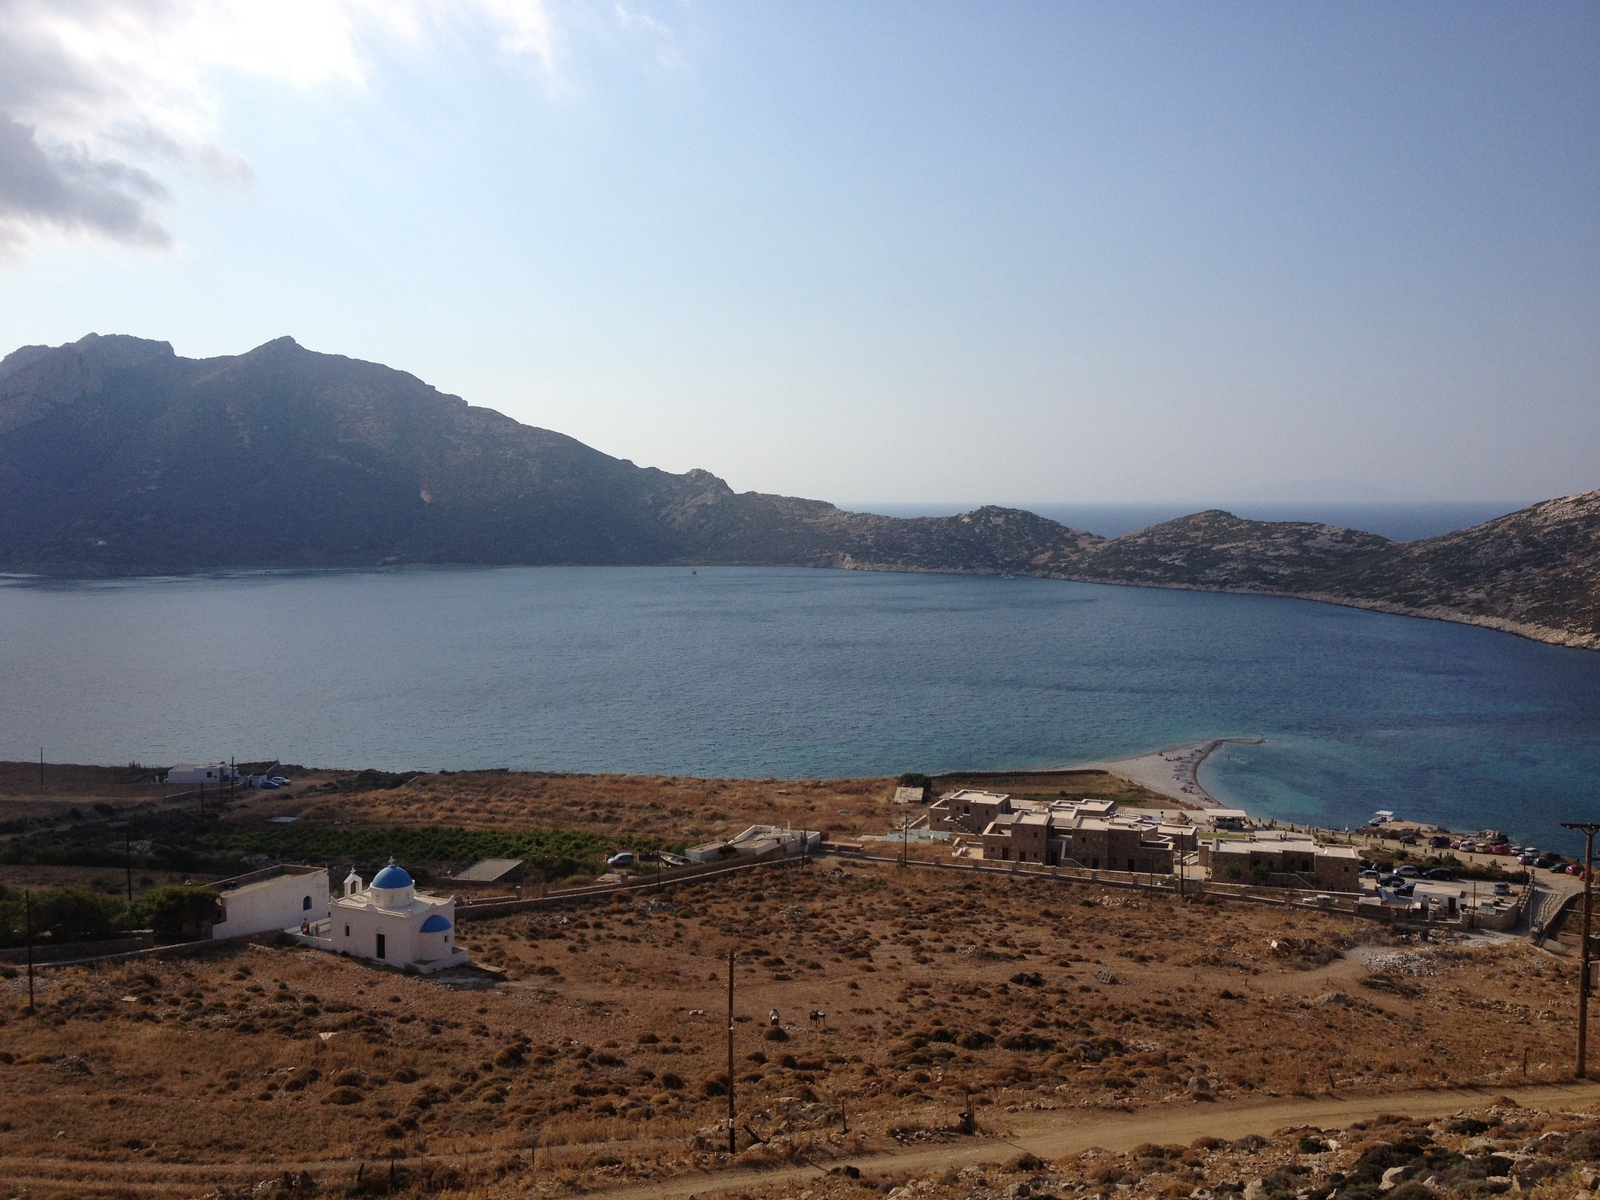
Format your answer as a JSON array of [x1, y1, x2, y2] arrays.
[[0, 334, 1099, 574]]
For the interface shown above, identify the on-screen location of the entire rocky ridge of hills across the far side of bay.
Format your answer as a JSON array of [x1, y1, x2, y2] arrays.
[[0, 334, 1600, 650]]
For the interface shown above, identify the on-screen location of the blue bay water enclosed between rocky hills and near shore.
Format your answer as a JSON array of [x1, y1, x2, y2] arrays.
[[0, 568, 1600, 846]]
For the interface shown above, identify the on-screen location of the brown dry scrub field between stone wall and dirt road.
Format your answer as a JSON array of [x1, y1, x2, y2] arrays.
[[0, 864, 1573, 1195]]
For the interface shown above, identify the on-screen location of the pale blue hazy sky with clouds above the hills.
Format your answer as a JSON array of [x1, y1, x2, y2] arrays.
[[0, 0, 1600, 504]]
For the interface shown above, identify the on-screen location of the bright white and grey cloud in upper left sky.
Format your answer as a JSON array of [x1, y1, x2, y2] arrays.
[[0, 0, 555, 258]]
